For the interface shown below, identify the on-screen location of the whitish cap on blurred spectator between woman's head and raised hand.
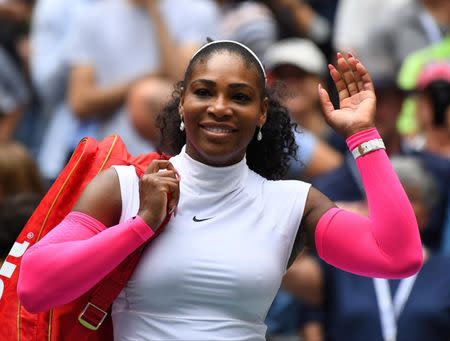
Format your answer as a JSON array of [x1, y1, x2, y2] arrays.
[[264, 38, 327, 76]]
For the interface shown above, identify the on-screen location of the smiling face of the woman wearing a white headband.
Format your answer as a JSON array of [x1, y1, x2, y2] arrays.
[[180, 51, 268, 166]]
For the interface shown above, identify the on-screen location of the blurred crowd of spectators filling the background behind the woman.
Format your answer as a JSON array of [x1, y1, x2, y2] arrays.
[[0, 0, 450, 341]]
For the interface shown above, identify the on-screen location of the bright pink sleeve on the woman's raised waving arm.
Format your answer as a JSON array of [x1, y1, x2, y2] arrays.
[[315, 129, 422, 278]]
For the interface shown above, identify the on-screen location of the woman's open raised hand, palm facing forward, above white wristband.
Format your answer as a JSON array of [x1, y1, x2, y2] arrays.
[[319, 53, 376, 138]]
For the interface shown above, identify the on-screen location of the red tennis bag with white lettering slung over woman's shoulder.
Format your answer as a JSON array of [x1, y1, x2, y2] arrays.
[[0, 135, 167, 341]]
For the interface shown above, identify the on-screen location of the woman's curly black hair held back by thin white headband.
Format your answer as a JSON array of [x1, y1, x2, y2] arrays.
[[156, 42, 297, 180]]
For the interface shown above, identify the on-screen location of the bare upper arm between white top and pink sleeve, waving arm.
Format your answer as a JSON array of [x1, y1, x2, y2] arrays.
[[302, 186, 336, 248]]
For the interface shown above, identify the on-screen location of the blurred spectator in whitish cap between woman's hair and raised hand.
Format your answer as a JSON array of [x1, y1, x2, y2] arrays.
[[264, 38, 346, 179]]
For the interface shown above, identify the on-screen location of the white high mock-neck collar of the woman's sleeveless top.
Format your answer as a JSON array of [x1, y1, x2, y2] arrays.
[[175, 146, 249, 195]]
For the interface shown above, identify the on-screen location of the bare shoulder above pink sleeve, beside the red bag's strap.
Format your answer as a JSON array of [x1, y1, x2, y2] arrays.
[[73, 168, 122, 226]]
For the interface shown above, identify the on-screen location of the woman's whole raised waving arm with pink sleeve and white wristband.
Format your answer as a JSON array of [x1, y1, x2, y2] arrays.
[[302, 54, 423, 278]]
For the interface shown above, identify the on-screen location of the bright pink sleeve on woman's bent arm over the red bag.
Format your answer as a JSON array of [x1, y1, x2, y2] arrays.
[[17, 212, 154, 313]]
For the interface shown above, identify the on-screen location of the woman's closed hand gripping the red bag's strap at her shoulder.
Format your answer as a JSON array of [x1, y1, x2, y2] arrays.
[[138, 160, 180, 231]]
